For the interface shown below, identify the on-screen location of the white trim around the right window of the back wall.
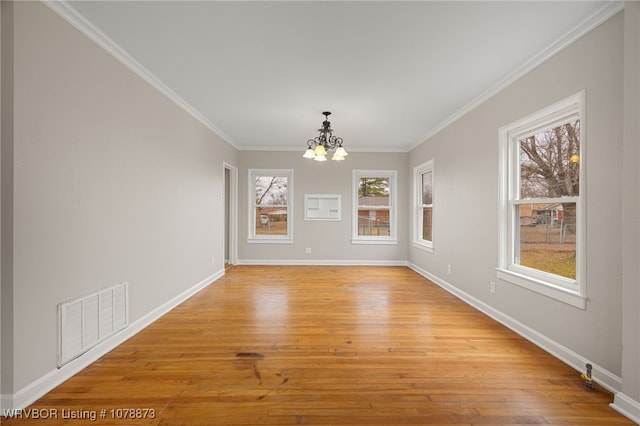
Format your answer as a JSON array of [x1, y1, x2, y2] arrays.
[[351, 170, 398, 244]]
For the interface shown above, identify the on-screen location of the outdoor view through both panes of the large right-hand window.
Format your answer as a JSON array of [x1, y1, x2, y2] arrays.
[[515, 119, 580, 279]]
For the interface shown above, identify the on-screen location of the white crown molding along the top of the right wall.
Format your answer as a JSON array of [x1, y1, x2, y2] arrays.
[[407, 0, 624, 151]]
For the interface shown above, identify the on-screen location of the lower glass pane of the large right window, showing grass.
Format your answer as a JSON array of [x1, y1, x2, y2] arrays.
[[515, 203, 576, 279]]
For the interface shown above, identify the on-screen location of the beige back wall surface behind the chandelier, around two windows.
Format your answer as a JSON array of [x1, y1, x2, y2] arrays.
[[238, 150, 409, 264]]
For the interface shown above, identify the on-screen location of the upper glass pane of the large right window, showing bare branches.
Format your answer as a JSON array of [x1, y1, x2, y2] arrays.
[[519, 120, 580, 199]]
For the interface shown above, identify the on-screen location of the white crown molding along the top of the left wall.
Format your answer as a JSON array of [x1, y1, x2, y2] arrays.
[[41, 0, 240, 149]]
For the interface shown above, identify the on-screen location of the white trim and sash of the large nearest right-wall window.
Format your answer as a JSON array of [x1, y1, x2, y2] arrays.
[[496, 90, 587, 309]]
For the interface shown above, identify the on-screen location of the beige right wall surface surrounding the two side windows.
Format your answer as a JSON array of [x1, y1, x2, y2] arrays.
[[409, 8, 623, 388]]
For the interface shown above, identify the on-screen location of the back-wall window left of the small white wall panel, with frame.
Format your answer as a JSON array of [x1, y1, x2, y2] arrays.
[[248, 169, 293, 243]]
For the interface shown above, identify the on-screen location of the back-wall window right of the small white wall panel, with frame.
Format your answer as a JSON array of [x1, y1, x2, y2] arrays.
[[352, 170, 397, 244]]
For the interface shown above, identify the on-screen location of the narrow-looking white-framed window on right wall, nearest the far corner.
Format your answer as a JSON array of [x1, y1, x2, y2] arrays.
[[413, 160, 433, 252]]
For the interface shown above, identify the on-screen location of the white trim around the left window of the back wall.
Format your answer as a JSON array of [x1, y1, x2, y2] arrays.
[[247, 169, 294, 244]]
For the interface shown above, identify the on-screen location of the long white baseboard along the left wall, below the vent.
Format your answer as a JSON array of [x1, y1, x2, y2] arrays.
[[0, 269, 224, 410]]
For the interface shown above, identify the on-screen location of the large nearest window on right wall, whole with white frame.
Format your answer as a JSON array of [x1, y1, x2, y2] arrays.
[[498, 92, 586, 309]]
